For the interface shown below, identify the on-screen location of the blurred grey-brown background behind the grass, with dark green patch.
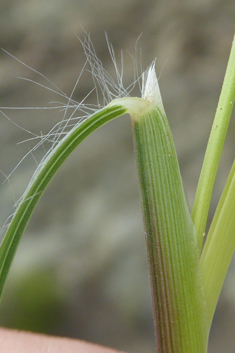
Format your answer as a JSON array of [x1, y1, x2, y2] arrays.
[[0, 0, 235, 353]]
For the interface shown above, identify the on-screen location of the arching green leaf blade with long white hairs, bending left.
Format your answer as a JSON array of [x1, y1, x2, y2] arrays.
[[0, 104, 127, 298]]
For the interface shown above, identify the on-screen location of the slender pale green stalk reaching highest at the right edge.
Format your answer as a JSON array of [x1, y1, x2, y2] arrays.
[[192, 32, 235, 250]]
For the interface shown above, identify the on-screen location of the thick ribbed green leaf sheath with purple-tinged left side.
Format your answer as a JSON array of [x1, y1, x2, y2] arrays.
[[132, 105, 208, 353]]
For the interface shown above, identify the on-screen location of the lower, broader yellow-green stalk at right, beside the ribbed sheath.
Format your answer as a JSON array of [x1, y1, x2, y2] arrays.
[[200, 158, 235, 326]]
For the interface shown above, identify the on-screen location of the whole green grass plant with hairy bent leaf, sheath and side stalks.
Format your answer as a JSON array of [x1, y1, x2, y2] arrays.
[[0, 36, 235, 353]]
